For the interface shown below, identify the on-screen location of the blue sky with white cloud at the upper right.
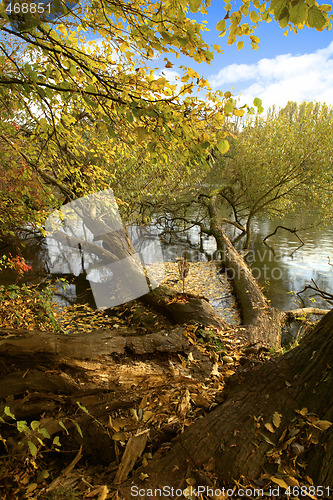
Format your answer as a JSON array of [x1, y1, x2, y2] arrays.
[[154, 0, 333, 109]]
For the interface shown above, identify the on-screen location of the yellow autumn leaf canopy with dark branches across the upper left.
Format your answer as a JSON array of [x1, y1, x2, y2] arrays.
[[0, 0, 331, 234]]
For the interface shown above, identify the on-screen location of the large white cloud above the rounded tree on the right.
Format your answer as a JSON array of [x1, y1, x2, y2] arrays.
[[208, 42, 333, 109]]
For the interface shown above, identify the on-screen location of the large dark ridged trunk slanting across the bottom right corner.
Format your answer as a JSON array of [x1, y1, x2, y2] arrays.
[[120, 311, 333, 498]]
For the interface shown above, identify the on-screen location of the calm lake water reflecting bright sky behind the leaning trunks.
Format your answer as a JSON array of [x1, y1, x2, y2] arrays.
[[158, 216, 333, 310]]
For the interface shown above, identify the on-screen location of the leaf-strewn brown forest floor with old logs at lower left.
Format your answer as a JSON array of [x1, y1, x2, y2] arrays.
[[0, 263, 269, 500]]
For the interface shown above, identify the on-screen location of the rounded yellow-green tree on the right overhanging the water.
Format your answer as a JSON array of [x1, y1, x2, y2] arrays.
[[204, 102, 333, 248]]
